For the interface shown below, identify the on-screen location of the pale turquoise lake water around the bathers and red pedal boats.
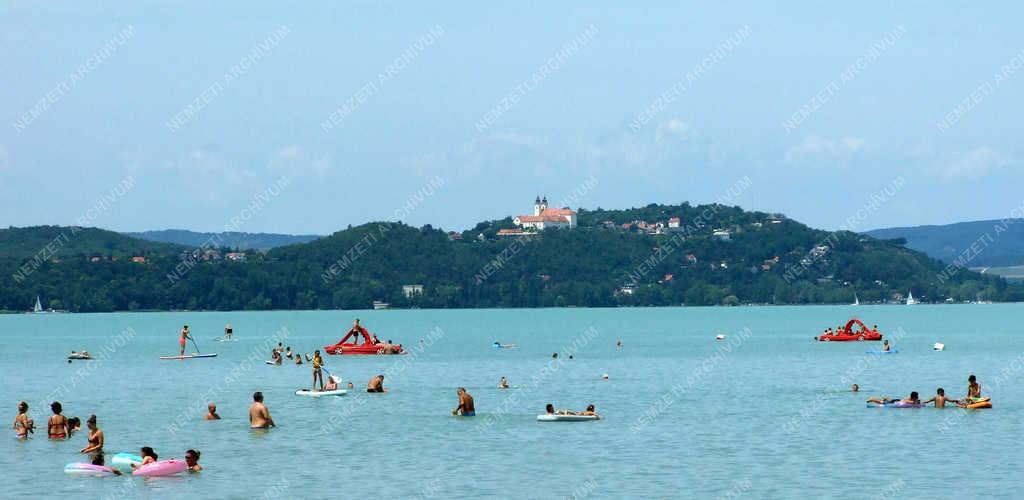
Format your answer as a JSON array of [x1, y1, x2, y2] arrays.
[[0, 304, 1024, 498]]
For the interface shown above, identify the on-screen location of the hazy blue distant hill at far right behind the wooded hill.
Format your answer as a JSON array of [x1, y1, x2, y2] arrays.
[[866, 218, 1024, 267]]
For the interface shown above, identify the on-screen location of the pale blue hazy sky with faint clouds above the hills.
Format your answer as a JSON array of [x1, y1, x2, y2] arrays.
[[0, 0, 1024, 234]]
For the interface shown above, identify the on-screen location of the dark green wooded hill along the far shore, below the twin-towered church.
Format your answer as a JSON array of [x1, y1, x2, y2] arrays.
[[0, 204, 1024, 311]]
